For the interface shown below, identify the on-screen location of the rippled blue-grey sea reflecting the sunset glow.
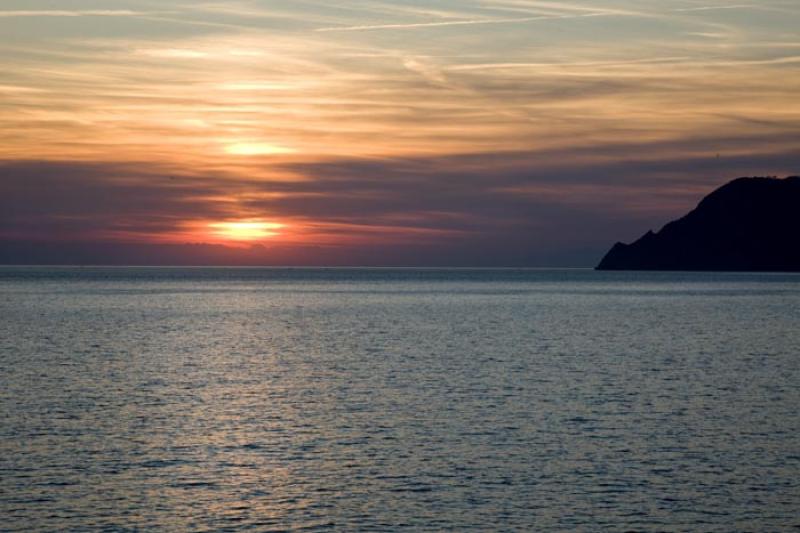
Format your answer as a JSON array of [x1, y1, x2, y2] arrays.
[[0, 268, 800, 532]]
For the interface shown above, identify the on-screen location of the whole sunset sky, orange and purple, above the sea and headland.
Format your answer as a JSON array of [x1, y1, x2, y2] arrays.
[[0, 0, 800, 267]]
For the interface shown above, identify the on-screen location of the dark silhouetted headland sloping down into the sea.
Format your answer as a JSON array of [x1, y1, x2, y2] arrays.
[[597, 176, 800, 272]]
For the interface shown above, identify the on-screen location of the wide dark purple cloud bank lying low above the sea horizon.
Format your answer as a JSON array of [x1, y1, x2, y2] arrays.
[[0, 125, 800, 266]]
